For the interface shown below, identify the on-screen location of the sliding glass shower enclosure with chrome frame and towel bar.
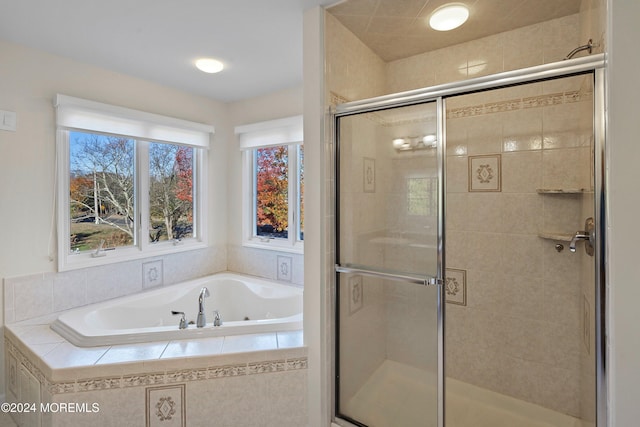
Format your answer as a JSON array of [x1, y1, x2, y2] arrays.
[[332, 56, 606, 427]]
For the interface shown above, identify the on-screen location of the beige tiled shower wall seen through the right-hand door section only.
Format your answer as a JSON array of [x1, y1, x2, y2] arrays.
[[446, 76, 593, 417]]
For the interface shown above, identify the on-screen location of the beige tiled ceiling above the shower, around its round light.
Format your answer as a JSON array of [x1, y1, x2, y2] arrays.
[[328, 0, 581, 61]]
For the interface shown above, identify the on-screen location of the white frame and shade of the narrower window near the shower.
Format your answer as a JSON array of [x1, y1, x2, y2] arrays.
[[235, 116, 304, 254]]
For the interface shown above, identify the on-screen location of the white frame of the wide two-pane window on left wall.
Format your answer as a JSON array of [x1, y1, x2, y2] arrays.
[[55, 95, 213, 271]]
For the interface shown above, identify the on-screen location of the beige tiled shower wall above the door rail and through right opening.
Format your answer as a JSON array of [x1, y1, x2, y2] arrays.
[[325, 0, 605, 420]]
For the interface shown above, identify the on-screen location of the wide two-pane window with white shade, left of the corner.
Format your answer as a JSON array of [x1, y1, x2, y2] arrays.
[[56, 95, 213, 271]]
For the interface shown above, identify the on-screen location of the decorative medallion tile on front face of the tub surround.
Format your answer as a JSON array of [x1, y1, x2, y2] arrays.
[[145, 384, 187, 427]]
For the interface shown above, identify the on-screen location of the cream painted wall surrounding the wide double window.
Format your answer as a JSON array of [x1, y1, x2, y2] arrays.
[[0, 41, 232, 393]]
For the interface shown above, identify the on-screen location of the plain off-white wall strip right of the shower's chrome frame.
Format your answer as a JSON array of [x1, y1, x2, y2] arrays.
[[607, 0, 640, 427]]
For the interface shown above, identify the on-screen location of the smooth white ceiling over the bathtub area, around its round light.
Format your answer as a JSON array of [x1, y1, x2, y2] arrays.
[[0, 0, 335, 102]]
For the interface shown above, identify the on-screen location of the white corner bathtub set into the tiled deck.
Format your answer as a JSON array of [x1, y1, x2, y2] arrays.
[[51, 273, 303, 347]]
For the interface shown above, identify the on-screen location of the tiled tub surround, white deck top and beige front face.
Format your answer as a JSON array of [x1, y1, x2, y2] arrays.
[[5, 319, 307, 427]]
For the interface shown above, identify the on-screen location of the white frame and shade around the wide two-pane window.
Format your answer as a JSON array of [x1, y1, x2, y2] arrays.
[[54, 95, 214, 271]]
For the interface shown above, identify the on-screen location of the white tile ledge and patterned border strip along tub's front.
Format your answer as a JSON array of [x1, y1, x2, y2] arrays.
[[4, 319, 307, 394]]
